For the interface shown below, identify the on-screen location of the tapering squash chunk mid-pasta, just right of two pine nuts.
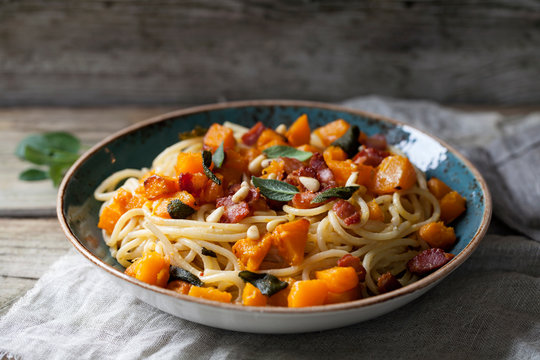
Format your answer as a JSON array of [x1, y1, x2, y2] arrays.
[[272, 219, 310, 266]]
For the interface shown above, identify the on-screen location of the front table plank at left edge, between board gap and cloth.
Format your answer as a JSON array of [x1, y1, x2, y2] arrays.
[[0, 219, 71, 316]]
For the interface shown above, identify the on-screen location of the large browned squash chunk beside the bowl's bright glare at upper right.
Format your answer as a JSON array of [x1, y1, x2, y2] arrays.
[[369, 155, 416, 195]]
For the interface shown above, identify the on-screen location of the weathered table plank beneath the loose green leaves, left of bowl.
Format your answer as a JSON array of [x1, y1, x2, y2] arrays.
[[0, 107, 173, 217]]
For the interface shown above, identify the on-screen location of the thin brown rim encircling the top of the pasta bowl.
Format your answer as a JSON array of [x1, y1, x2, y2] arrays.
[[56, 99, 492, 314]]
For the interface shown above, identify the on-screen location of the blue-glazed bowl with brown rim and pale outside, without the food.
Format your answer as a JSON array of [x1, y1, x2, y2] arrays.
[[57, 100, 491, 333]]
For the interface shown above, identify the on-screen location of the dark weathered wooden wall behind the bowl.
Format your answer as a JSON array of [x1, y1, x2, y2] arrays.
[[0, 0, 540, 105]]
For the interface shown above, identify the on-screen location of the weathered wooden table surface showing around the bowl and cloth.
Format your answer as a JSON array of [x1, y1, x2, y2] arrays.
[[0, 107, 538, 316]]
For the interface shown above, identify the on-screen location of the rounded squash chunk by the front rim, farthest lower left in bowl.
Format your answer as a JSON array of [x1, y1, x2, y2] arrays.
[[125, 251, 170, 287]]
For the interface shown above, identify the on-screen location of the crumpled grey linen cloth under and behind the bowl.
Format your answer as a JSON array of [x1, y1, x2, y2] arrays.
[[0, 97, 540, 360]]
